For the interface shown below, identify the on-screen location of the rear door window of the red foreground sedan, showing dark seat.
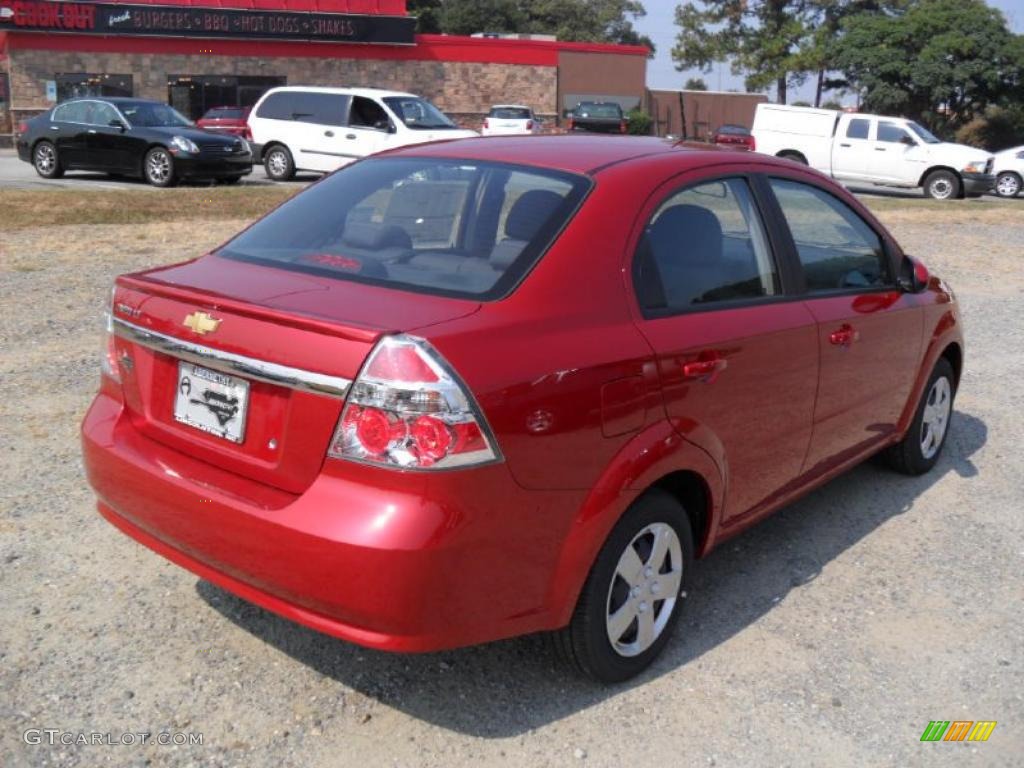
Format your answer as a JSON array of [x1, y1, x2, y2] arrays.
[[634, 178, 781, 313]]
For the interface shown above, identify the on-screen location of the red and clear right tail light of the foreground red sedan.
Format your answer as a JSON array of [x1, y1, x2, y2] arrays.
[[328, 336, 501, 470]]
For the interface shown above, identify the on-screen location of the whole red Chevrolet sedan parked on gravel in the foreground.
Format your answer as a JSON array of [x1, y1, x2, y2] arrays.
[[82, 136, 964, 681]]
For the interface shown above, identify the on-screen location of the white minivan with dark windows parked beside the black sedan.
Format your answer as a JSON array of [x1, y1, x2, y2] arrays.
[[249, 86, 477, 181]]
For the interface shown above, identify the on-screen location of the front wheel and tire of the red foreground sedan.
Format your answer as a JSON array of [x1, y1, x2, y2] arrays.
[[885, 357, 956, 475]]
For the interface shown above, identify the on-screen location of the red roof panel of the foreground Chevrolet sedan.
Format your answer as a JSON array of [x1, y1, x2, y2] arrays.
[[386, 134, 765, 174]]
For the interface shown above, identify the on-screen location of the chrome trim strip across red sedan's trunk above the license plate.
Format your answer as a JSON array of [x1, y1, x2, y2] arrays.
[[114, 317, 352, 399]]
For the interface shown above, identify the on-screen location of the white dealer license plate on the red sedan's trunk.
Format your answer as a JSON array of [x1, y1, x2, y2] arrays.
[[174, 361, 249, 442]]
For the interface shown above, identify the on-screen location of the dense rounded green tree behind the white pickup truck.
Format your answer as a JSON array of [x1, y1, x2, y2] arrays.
[[833, 0, 1024, 132]]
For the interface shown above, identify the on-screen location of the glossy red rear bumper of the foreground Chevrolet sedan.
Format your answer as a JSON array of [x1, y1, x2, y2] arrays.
[[82, 393, 582, 651]]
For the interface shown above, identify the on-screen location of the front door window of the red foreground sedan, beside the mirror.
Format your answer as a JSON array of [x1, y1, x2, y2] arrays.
[[770, 178, 893, 293]]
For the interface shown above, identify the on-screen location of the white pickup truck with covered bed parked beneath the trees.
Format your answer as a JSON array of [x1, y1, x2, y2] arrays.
[[752, 103, 995, 200]]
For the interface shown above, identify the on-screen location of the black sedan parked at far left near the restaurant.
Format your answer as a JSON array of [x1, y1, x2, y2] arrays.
[[17, 98, 253, 186]]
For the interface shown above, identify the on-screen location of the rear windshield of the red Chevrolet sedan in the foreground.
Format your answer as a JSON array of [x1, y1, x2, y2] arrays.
[[218, 158, 590, 301]]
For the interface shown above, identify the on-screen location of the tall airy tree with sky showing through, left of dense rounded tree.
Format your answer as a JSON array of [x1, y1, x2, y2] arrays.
[[672, 0, 818, 103]]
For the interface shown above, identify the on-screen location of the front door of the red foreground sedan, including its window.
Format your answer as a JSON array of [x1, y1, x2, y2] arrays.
[[769, 177, 924, 474]]
